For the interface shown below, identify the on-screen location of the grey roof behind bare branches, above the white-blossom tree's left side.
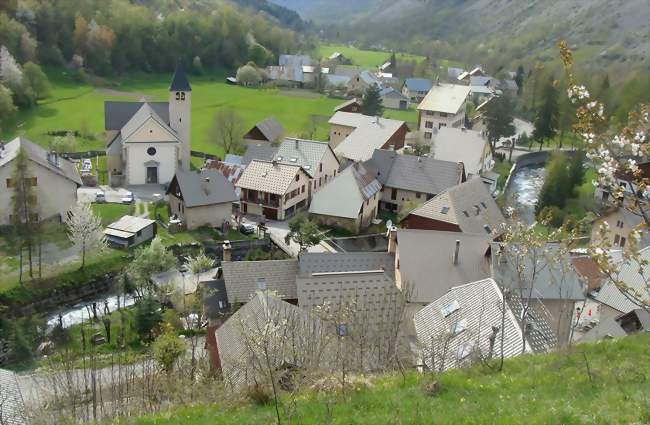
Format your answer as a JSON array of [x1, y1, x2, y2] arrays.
[[492, 242, 585, 301]]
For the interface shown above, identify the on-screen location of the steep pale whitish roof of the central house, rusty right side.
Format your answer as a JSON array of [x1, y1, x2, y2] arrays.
[[309, 164, 381, 219]]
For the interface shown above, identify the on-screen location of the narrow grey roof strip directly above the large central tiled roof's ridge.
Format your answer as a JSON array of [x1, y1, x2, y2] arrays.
[[299, 252, 395, 277]]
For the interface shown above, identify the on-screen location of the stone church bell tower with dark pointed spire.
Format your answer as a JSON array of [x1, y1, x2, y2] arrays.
[[169, 63, 192, 171]]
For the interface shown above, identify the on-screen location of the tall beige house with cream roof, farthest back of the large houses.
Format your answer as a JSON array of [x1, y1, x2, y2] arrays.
[[418, 83, 470, 140]]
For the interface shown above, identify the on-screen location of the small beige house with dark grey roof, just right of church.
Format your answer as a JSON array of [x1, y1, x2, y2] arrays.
[[167, 170, 238, 230]]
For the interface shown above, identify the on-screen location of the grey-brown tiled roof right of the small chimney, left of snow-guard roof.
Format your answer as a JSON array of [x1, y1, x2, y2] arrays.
[[222, 259, 298, 304]]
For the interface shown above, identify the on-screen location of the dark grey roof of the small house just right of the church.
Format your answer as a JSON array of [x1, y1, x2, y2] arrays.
[[167, 170, 237, 208]]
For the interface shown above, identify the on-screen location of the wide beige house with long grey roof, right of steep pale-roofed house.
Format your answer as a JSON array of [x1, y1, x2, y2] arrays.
[[364, 149, 465, 213]]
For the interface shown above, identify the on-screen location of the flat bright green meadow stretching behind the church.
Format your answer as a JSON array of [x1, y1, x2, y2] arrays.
[[2, 70, 416, 159]]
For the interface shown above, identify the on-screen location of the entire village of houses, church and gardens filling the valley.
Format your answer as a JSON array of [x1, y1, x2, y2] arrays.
[[0, 48, 650, 425]]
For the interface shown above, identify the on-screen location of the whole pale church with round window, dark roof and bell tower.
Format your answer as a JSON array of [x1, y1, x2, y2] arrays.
[[104, 65, 192, 187]]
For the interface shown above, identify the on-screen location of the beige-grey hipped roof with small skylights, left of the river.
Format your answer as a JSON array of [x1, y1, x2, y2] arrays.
[[409, 178, 506, 236]]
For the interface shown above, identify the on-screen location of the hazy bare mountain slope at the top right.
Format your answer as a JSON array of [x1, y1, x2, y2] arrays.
[[298, 0, 650, 66]]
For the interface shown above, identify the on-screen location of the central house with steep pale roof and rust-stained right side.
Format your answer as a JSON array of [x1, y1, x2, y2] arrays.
[[309, 163, 381, 233]]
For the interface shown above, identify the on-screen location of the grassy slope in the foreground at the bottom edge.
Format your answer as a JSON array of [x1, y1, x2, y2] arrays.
[[123, 334, 650, 425]]
